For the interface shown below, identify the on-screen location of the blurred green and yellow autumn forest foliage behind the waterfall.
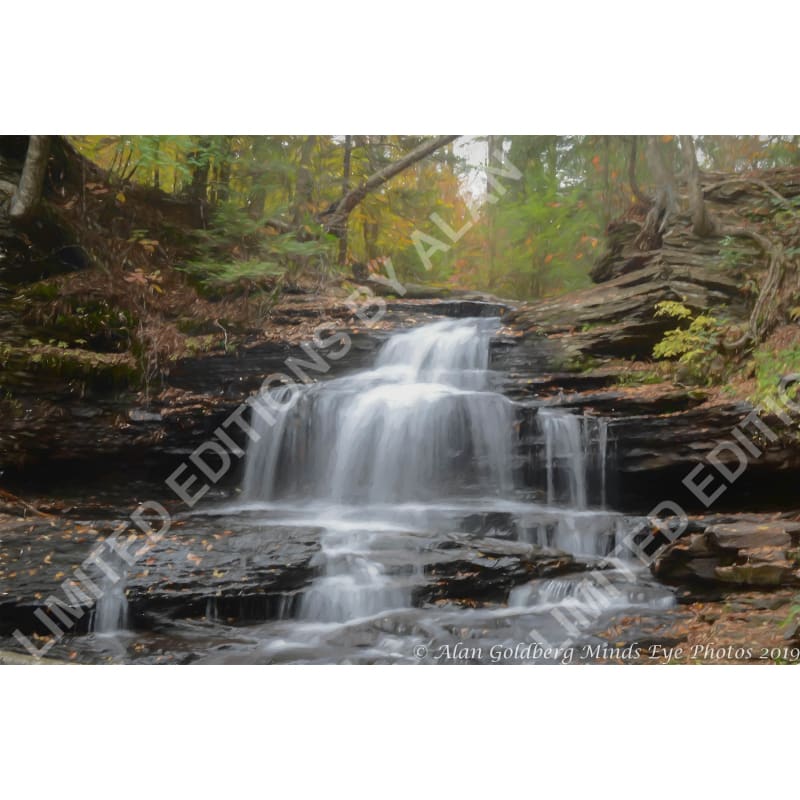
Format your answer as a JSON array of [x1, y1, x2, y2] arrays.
[[67, 135, 800, 299]]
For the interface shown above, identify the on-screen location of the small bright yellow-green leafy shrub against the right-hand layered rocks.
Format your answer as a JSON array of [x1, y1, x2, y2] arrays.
[[653, 301, 722, 382]]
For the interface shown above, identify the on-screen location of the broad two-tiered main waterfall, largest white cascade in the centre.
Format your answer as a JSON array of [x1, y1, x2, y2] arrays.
[[243, 319, 513, 504]]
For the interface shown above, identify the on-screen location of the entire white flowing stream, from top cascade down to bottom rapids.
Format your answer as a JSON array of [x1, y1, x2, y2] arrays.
[[81, 319, 674, 663]]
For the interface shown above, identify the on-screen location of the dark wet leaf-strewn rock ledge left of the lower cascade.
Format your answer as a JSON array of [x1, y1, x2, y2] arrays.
[[0, 518, 321, 635]]
